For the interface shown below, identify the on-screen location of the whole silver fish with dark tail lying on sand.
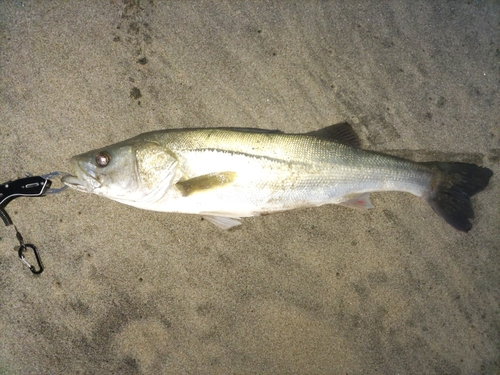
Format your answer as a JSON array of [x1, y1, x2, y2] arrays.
[[62, 122, 493, 232]]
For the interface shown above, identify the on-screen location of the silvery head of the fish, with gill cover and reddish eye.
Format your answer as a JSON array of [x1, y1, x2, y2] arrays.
[[62, 140, 178, 204]]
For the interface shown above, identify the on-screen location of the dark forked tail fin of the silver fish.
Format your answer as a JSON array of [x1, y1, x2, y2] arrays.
[[422, 162, 493, 232]]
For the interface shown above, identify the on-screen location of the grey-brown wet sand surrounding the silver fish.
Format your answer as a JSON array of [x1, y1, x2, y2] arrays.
[[0, 0, 500, 374]]
